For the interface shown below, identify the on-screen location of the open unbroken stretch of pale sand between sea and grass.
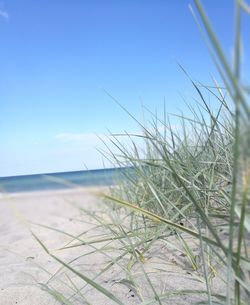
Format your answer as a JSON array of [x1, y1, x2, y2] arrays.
[[0, 188, 107, 305]]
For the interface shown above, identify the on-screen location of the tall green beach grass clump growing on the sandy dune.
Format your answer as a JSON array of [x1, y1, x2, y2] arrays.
[[34, 0, 250, 305]]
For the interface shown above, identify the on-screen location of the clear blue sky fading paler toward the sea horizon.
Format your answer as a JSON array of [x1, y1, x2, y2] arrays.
[[0, 0, 233, 176]]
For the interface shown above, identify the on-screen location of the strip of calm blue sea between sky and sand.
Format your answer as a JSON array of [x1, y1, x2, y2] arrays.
[[0, 168, 131, 193]]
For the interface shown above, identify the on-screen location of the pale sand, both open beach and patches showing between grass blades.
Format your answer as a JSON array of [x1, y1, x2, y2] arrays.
[[0, 188, 223, 305]]
